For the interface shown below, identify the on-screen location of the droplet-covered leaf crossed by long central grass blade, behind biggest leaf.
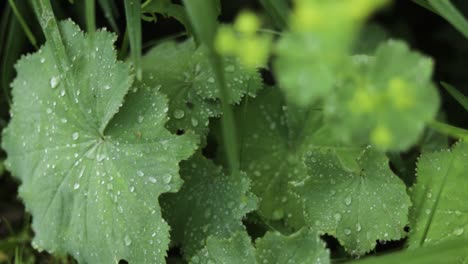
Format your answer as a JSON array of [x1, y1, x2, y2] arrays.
[[143, 40, 262, 136]]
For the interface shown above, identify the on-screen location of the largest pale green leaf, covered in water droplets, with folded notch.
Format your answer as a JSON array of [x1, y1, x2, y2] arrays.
[[3, 22, 196, 263]]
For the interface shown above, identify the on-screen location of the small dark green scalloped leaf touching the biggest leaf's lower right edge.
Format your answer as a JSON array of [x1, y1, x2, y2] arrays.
[[162, 154, 257, 259]]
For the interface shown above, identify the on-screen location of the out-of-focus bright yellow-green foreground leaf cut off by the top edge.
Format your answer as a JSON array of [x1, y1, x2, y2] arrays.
[[274, 0, 386, 106]]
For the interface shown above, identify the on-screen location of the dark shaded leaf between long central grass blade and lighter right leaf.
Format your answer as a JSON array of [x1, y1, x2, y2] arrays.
[[223, 87, 321, 226]]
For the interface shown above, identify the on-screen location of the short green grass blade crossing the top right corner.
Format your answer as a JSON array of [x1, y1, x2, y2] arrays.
[[428, 0, 468, 38]]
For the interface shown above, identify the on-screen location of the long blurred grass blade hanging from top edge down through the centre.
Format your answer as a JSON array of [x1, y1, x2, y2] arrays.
[[183, 0, 239, 175]]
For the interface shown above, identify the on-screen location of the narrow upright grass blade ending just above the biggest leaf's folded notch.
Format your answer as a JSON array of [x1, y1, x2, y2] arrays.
[[124, 0, 142, 80]]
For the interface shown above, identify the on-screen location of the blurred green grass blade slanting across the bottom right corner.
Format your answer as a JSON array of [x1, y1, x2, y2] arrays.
[[351, 237, 468, 264]]
